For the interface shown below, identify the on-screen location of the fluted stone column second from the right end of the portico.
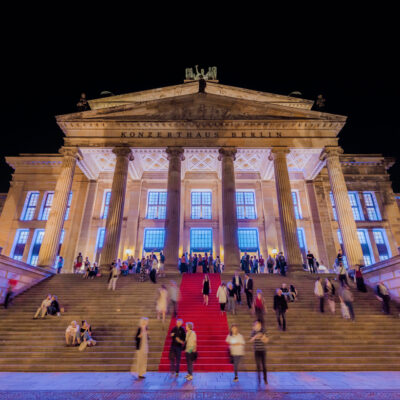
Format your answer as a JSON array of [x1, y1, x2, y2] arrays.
[[270, 147, 303, 269]]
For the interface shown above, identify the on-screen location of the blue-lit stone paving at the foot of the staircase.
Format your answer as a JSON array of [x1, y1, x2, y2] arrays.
[[0, 371, 400, 400]]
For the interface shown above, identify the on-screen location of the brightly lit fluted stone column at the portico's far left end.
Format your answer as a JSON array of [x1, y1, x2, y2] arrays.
[[38, 147, 80, 268]]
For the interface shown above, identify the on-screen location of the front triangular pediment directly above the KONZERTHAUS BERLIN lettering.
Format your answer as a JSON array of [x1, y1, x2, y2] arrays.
[[58, 92, 345, 122]]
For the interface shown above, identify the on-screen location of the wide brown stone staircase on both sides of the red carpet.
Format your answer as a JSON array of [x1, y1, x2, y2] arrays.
[[0, 272, 400, 372]]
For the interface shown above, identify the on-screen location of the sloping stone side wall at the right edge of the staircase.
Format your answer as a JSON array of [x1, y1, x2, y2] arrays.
[[362, 255, 400, 302]]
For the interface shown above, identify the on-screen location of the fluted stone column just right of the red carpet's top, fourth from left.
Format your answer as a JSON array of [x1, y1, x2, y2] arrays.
[[218, 147, 240, 272]]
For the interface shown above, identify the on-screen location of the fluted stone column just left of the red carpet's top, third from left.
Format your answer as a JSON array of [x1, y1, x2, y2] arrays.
[[164, 147, 185, 271]]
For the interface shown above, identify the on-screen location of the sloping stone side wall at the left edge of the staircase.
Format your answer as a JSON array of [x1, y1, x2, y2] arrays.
[[0, 254, 54, 304]]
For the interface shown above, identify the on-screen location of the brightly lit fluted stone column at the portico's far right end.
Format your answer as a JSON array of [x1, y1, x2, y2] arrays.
[[323, 146, 364, 268]]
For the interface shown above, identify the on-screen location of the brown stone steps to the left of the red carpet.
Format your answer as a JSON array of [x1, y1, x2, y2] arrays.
[[0, 274, 180, 372]]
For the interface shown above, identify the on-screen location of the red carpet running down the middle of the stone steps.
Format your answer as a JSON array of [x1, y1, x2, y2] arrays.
[[158, 273, 233, 372]]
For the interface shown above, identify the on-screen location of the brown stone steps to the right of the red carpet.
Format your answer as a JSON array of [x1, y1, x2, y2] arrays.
[[222, 272, 400, 371]]
